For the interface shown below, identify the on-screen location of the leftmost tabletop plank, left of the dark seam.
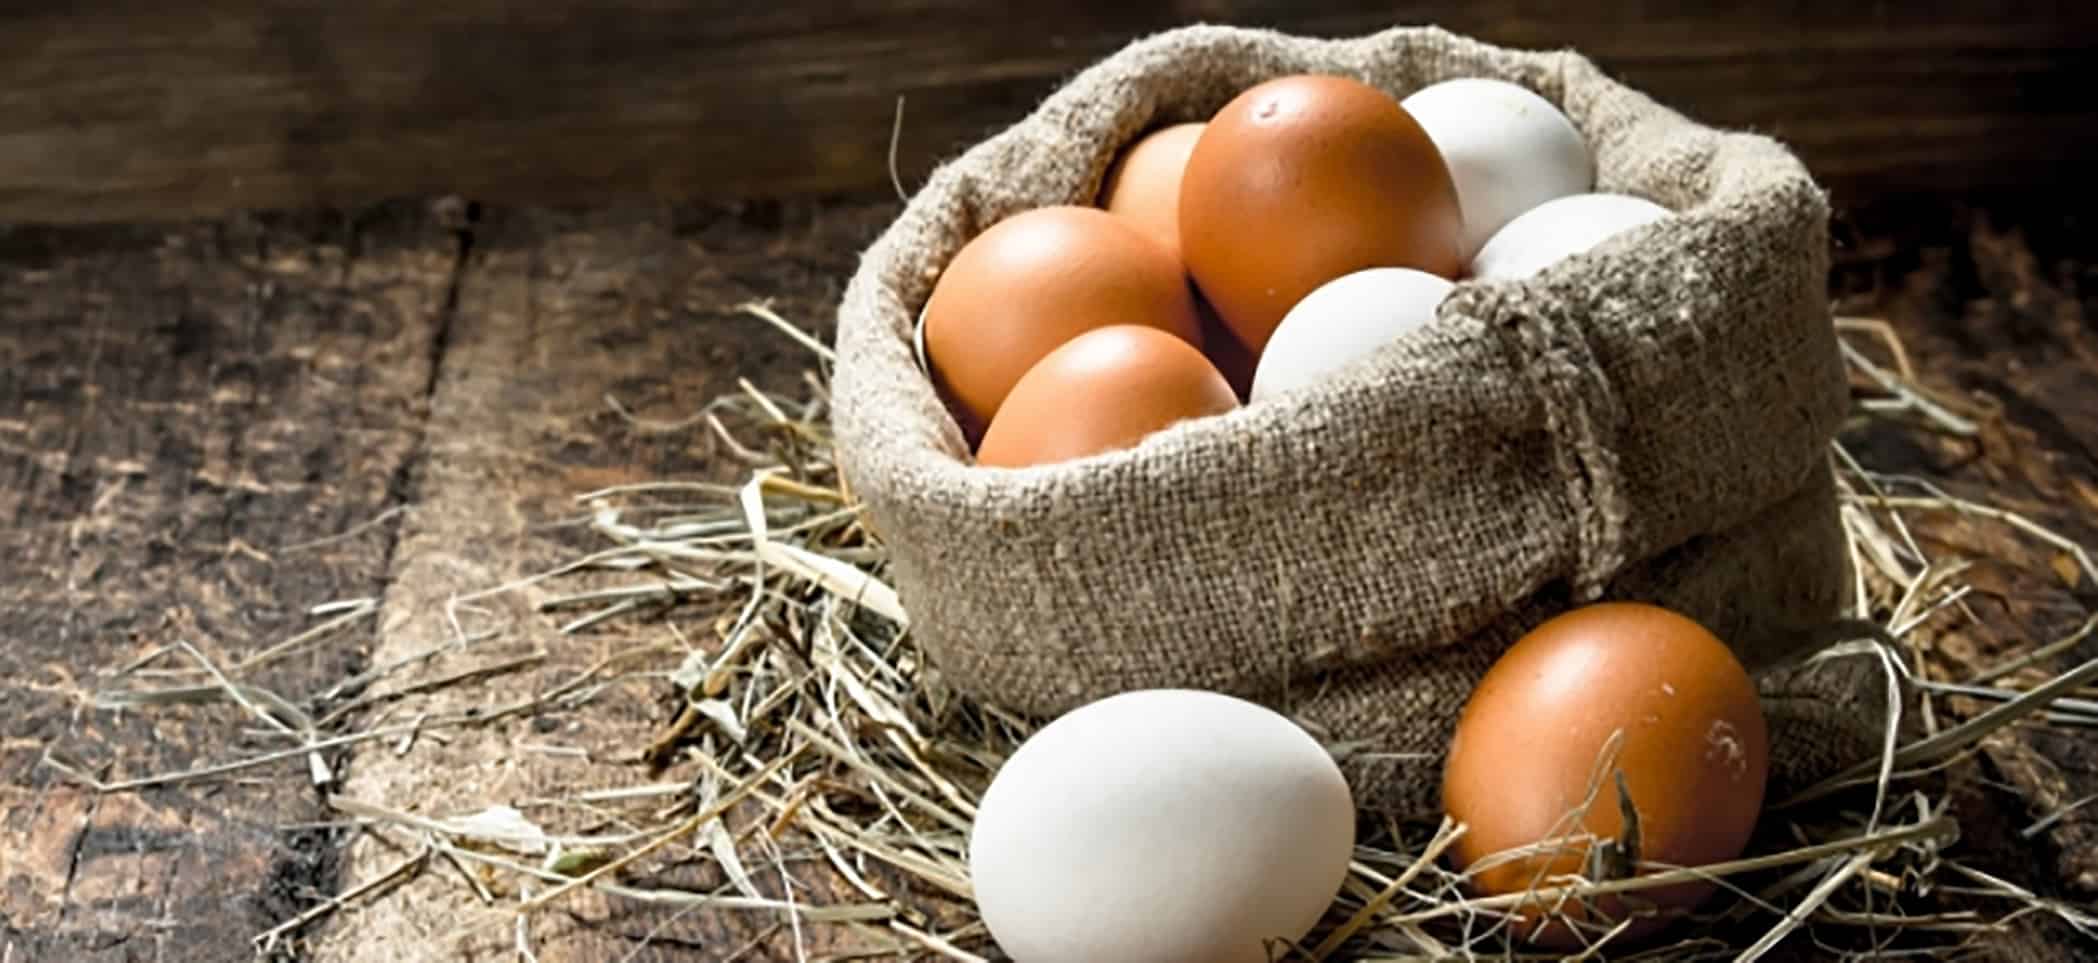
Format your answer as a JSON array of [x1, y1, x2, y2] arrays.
[[0, 212, 451, 961]]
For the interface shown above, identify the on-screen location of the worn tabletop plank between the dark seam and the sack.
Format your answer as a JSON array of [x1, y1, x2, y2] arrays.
[[313, 204, 894, 963]]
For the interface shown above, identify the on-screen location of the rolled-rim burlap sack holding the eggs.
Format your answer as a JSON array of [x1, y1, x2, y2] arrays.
[[835, 27, 1848, 814]]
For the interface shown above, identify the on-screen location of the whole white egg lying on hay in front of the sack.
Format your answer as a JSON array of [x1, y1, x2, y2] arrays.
[[969, 688, 1355, 963]]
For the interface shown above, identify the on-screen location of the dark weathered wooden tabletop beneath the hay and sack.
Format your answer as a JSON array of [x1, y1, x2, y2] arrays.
[[0, 191, 2098, 961]]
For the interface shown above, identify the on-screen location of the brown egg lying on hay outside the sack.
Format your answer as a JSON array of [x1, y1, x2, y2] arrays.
[[1443, 602, 1769, 948]]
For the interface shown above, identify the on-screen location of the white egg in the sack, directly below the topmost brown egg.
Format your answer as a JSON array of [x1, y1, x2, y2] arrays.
[[1248, 269, 1456, 403]]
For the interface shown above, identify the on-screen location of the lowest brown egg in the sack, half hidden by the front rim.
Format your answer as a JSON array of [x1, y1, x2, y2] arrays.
[[976, 325, 1238, 468]]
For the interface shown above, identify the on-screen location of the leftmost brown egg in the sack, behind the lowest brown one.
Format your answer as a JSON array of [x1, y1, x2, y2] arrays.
[[925, 206, 1202, 438]]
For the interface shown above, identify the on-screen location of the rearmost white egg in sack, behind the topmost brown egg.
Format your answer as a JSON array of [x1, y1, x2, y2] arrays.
[[1399, 78, 1594, 258]]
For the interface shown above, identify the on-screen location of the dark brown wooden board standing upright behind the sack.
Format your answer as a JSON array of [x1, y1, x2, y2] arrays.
[[0, 0, 2098, 222]]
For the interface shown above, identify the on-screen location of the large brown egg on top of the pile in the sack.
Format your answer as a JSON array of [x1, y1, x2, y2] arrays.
[[1179, 76, 1464, 357]]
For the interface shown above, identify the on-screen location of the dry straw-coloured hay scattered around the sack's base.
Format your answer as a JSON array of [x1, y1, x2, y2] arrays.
[[46, 304, 2098, 961]]
